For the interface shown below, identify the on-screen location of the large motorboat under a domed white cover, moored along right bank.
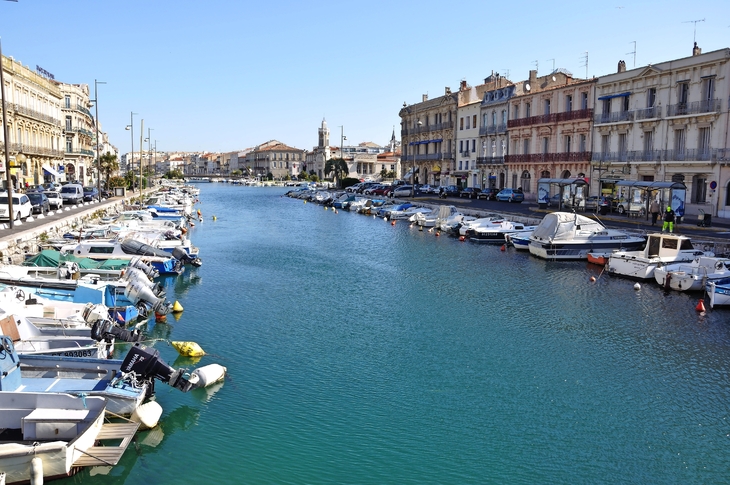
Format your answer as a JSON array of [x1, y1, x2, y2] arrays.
[[530, 212, 645, 260]]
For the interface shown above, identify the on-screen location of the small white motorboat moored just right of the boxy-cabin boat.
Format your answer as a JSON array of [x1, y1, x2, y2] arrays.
[[654, 256, 730, 291]]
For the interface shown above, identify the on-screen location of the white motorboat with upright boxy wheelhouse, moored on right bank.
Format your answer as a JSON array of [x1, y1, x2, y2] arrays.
[[606, 233, 714, 280]]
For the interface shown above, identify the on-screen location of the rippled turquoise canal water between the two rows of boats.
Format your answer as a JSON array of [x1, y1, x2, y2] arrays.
[[65, 184, 730, 485]]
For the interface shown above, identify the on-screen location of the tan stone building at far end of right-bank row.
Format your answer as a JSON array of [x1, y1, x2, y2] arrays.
[[398, 87, 458, 185]]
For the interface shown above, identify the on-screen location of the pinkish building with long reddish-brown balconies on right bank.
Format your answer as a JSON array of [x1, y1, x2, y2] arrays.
[[505, 69, 597, 200]]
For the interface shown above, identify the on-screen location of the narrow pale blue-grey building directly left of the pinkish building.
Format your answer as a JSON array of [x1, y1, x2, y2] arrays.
[[477, 73, 526, 189]]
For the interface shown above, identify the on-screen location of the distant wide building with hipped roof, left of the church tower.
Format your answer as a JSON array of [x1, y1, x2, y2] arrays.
[[239, 140, 305, 180]]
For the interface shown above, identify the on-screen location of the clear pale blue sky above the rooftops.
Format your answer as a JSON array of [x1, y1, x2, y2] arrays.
[[0, 0, 730, 153]]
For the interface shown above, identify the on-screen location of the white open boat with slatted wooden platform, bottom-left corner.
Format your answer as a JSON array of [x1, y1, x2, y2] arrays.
[[0, 392, 139, 485]]
